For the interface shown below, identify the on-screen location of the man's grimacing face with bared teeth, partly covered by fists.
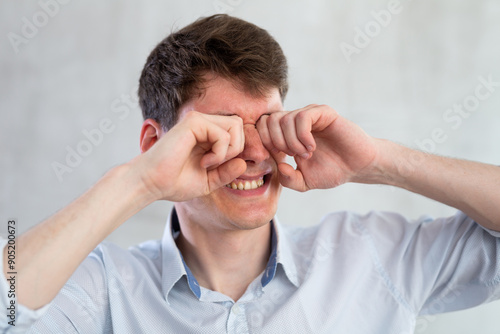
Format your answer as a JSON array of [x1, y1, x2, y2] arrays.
[[175, 77, 285, 231]]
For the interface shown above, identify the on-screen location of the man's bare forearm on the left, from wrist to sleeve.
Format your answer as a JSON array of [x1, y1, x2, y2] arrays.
[[3, 160, 152, 309]]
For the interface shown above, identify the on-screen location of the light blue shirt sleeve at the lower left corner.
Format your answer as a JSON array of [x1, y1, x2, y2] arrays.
[[0, 239, 111, 334]]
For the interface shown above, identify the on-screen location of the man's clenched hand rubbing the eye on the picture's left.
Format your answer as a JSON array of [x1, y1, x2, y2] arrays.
[[136, 111, 246, 202]]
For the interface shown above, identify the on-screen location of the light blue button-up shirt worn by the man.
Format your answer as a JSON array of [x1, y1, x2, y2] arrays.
[[0, 212, 500, 334]]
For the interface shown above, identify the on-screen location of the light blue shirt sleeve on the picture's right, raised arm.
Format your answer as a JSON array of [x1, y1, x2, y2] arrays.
[[364, 212, 500, 315]]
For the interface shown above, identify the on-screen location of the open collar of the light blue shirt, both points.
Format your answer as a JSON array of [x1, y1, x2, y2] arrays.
[[161, 208, 299, 303]]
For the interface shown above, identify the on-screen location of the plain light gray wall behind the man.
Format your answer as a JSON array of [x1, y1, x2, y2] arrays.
[[0, 0, 500, 334]]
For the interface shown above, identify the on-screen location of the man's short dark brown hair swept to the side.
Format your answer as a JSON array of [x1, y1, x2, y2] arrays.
[[139, 14, 288, 130]]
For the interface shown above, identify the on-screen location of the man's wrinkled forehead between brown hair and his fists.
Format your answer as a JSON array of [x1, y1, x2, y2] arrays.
[[179, 77, 283, 123]]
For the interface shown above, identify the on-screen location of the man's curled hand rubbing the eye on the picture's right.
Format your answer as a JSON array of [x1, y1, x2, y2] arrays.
[[257, 105, 377, 191]]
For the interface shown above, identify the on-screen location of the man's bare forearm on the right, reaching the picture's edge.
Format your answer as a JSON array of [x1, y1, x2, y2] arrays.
[[358, 140, 500, 230]]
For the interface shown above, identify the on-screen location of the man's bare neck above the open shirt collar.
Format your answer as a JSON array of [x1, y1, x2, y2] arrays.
[[176, 217, 271, 301]]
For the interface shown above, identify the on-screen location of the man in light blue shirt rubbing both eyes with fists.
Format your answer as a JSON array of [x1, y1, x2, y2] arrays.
[[1, 15, 500, 333]]
